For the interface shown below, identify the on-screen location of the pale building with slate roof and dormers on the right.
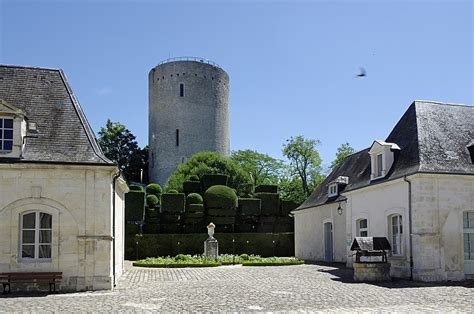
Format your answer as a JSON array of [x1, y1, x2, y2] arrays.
[[293, 101, 474, 281]]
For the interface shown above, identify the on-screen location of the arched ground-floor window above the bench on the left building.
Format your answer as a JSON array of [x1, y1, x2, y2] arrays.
[[20, 211, 53, 260]]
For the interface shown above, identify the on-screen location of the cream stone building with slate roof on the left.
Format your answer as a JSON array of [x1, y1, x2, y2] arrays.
[[0, 66, 128, 291]]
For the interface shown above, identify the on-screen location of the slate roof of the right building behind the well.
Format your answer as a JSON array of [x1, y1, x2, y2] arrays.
[[295, 101, 474, 211]]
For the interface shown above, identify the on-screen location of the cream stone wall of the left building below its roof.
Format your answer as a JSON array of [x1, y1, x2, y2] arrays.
[[0, 164, 126, 290]]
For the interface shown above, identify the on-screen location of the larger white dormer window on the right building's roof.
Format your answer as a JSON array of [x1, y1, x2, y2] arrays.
[[369, 141, 400, 180]]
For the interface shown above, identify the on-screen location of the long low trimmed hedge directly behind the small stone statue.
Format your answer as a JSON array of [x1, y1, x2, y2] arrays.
[[125, 233, 295, 260]]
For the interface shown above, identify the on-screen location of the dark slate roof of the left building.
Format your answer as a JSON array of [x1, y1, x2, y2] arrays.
[[0, 65, 114, 165]]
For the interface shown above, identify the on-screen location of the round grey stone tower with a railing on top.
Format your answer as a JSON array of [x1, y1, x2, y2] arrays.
[[148, 58, 229, 185]]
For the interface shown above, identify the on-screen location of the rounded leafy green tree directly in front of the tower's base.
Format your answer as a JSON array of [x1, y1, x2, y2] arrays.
[[165, 152, 251, 195]]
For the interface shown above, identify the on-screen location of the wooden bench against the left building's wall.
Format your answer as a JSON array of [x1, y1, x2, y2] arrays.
[[0, 272, 63, 294]]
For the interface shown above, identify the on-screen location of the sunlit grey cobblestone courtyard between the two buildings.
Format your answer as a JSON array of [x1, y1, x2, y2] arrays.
[[0, 265, 474, 313]]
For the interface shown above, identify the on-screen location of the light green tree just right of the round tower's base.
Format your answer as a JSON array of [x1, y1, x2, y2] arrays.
[[230, 149, 285, 187]]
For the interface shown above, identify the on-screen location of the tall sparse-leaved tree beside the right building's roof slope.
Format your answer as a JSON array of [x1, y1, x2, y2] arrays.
[[282, 135, 323, 197]]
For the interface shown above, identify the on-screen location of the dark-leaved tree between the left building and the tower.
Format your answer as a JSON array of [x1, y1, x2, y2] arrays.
[[97, 119, 148, 182]]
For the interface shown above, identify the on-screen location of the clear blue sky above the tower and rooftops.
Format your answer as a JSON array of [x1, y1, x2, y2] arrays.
[[0, 0, 474, 169]]
